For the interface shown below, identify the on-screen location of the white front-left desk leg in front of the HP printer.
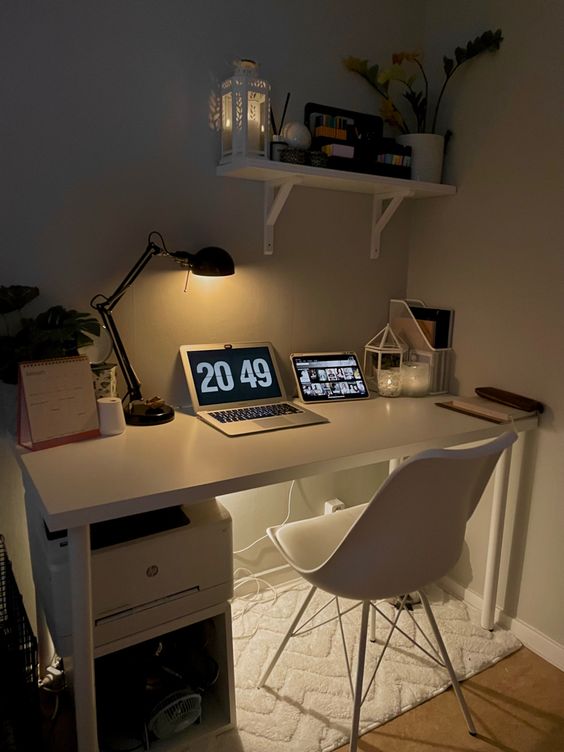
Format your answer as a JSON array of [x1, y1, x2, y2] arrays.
[[69, 525, 98, 752]]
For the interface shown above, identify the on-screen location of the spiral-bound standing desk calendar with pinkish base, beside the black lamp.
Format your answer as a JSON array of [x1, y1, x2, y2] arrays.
[[17, 355, 100, 449]]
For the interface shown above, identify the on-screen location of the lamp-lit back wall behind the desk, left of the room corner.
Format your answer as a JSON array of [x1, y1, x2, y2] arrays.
[[0, 0, 423, 628]]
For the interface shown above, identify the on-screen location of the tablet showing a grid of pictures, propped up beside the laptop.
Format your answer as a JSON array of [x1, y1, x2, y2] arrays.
[[290, 352, 369, 402]]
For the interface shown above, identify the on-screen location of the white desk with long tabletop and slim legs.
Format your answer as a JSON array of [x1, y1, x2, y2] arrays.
[[18, 395, 537, 752]]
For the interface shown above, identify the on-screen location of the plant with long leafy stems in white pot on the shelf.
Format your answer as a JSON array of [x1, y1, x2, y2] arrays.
[[343, 29, 503, 182]]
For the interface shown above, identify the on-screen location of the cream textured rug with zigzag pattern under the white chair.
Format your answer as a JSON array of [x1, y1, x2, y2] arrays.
[[197, 583, 520, 752]]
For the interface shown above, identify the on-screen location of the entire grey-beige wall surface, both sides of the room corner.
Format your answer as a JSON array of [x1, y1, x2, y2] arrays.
[[0, 0, 564, 656]]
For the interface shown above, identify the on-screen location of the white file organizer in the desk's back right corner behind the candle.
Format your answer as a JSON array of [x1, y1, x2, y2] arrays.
[[388, 299, 452, 394]]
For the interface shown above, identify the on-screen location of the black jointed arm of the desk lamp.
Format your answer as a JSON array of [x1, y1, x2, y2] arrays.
[[90, 237, 164, 401]]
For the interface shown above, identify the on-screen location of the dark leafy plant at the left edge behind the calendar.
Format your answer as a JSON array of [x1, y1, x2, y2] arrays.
[[0, 285, 100, 384]]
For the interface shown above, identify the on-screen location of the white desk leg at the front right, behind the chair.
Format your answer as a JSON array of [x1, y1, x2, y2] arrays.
[[481, 447, 511, 630]]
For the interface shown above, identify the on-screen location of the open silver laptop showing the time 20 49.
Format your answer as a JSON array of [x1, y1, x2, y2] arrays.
[[180, 342, 329, 436]]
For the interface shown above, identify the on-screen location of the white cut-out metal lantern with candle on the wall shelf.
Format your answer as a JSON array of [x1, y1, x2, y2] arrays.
[[221, 60, 270, 164]]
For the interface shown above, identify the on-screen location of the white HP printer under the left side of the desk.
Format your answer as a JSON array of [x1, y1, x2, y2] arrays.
[[27, 499, 233, 656]]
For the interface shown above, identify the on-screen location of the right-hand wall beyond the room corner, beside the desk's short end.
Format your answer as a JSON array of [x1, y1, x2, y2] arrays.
[[408, 0, 564, 645]]
